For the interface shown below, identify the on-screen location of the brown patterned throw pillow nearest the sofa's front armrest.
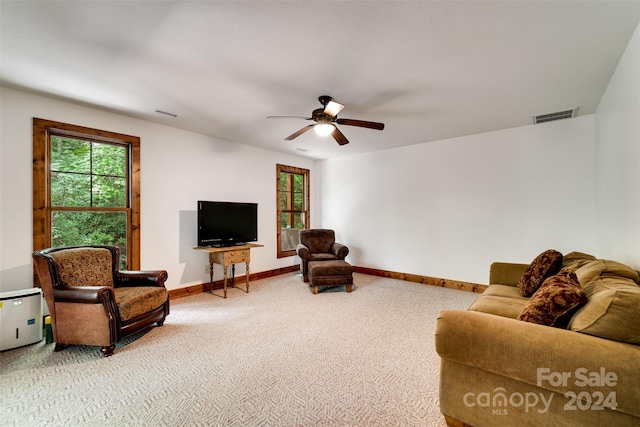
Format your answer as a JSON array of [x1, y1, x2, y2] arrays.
[[518, 268, 587, 328]]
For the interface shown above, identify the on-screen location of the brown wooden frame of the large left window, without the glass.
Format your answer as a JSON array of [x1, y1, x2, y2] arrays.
[[33, 117, 140, 270]]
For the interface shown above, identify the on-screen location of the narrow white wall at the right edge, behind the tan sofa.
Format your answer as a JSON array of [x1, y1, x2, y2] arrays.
[[596, 25, 640, 269]]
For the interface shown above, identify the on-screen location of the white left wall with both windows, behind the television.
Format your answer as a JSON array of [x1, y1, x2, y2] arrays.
[[0, 88, 317, 291]]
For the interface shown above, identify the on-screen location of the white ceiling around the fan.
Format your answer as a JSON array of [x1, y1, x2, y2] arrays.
[[0, 0, 640, 158]]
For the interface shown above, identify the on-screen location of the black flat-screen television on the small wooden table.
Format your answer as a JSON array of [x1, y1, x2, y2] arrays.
[[198, 200, 258, 247]]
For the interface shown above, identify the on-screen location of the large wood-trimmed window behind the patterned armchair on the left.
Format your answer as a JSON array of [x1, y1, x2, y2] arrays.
[[33, 118, 140, 270]]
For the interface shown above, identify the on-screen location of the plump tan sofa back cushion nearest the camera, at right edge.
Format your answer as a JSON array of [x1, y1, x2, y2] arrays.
[[569, 276, 640, 345]]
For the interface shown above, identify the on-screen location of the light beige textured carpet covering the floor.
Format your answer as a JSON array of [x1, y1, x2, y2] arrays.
[[0, 274, 477, 426]]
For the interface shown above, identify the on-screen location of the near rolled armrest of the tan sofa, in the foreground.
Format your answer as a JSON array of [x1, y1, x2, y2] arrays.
[[435, 310, 640, 416]]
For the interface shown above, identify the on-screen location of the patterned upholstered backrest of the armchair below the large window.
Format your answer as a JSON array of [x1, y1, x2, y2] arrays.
[[49, 248, 113, 288]]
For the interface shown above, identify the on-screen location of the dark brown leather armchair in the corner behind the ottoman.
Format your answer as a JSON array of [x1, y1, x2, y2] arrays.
[[296, 229, 349, 283]]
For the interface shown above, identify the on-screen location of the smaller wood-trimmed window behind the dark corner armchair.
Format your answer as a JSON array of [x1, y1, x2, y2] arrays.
[[276, 165, 309, 258]]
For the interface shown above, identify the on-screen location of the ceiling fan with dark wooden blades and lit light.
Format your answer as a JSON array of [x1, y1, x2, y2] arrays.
[[267, 95, 384, 145]]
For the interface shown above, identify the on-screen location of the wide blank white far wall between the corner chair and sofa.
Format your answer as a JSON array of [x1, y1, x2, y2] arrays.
[[319, 115, 596, 283]]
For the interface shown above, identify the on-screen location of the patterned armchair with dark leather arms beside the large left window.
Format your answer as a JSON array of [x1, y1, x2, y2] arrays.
[[33, 245, 169, 356]]
